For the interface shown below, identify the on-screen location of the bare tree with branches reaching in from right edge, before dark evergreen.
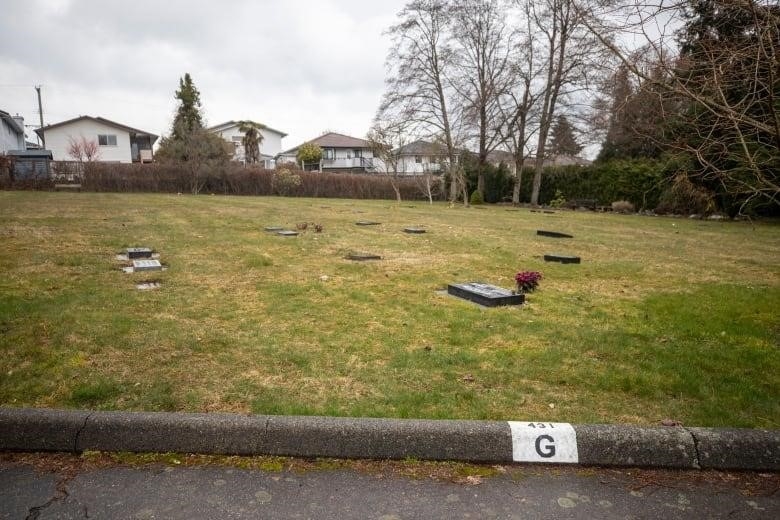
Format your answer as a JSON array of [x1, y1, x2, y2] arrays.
[[578, 0, 780, 211]]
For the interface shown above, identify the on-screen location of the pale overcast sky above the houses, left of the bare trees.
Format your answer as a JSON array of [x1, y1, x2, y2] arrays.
[[0, 0, 405, 148]]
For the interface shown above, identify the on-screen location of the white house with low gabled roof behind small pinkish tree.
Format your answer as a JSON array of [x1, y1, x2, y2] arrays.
[[35, 116, 157, 163]]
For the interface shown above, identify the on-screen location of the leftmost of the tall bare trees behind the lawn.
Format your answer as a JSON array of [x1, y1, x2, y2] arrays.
[[377, 0, 468, 204]]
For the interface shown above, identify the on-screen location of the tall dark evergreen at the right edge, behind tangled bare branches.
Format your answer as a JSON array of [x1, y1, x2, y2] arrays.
[[673, 0, 780, 214]]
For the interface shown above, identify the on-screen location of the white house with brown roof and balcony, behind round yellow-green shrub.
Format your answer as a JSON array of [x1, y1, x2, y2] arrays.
[[276, 132, 377, 172]]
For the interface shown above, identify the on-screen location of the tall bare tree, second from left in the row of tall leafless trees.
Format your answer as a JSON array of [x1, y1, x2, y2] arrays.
[[453, 0, 511, 197]]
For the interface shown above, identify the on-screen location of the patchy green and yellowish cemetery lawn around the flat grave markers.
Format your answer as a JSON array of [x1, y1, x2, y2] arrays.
[[0, 192, 780, 428]]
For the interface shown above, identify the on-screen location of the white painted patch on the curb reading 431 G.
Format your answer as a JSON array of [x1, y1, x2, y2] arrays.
[[509, 421, 579, 464]]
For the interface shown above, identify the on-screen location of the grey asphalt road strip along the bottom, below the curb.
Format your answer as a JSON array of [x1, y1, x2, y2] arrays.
[[0, 454, 780, 520]]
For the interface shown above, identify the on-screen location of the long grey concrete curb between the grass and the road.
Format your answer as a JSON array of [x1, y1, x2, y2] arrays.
[[0, 408, 780, 471]]
